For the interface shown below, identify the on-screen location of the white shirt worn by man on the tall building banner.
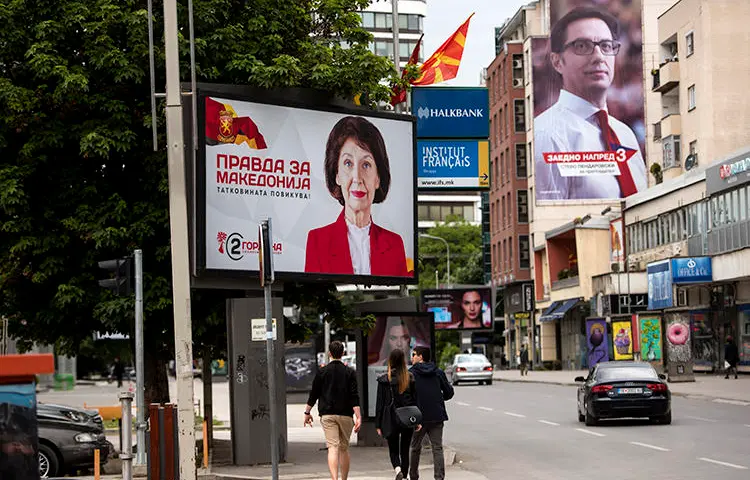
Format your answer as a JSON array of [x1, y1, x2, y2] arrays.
[[534, 90, 648, 200]]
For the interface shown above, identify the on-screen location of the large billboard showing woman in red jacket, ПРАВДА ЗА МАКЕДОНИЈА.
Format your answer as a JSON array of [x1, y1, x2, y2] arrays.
[[196, 89, 416, 284]]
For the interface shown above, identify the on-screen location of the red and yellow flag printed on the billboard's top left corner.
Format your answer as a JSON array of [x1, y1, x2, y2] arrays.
[[206, 97, 268, 149]]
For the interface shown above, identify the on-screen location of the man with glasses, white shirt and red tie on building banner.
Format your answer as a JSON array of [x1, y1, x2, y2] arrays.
[[534, 7, 648, 200]]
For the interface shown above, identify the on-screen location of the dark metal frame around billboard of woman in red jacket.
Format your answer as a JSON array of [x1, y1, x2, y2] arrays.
[[191, 83, 419, 285]]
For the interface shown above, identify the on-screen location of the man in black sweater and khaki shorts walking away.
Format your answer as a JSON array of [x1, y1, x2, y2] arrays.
[[303, 340, 362, 480]]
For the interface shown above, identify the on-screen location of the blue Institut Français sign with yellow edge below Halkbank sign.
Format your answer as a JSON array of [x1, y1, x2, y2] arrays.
[[417, 140, 490, 190]]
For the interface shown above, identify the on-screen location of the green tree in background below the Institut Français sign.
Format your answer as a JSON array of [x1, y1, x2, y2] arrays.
[[419, 219, 484, 289]]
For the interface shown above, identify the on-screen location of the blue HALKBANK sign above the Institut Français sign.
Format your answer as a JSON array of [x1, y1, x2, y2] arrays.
[[411, 87, 490, 138]]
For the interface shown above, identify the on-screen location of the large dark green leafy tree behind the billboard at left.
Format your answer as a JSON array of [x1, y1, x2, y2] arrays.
[[0, 0, 402, 402]]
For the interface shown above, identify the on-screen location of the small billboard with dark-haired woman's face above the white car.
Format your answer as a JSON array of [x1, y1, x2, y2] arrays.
[[422, 287, 492, 330]]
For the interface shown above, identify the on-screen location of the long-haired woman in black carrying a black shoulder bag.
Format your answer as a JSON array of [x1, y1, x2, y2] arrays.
[[375, 348, 422, 480]]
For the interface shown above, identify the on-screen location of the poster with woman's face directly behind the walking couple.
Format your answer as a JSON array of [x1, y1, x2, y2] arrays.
[[365, 313, 435, 417]]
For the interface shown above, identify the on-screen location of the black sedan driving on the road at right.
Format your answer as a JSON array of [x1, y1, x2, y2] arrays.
[[575, 362, 672, 426]]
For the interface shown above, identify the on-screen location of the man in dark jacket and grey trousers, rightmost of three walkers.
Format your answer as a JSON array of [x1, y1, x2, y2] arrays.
[[409, 347, 454, 480]]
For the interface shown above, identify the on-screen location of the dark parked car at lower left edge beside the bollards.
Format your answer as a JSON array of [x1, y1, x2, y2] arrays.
[[36, 402, 114, 478]]
